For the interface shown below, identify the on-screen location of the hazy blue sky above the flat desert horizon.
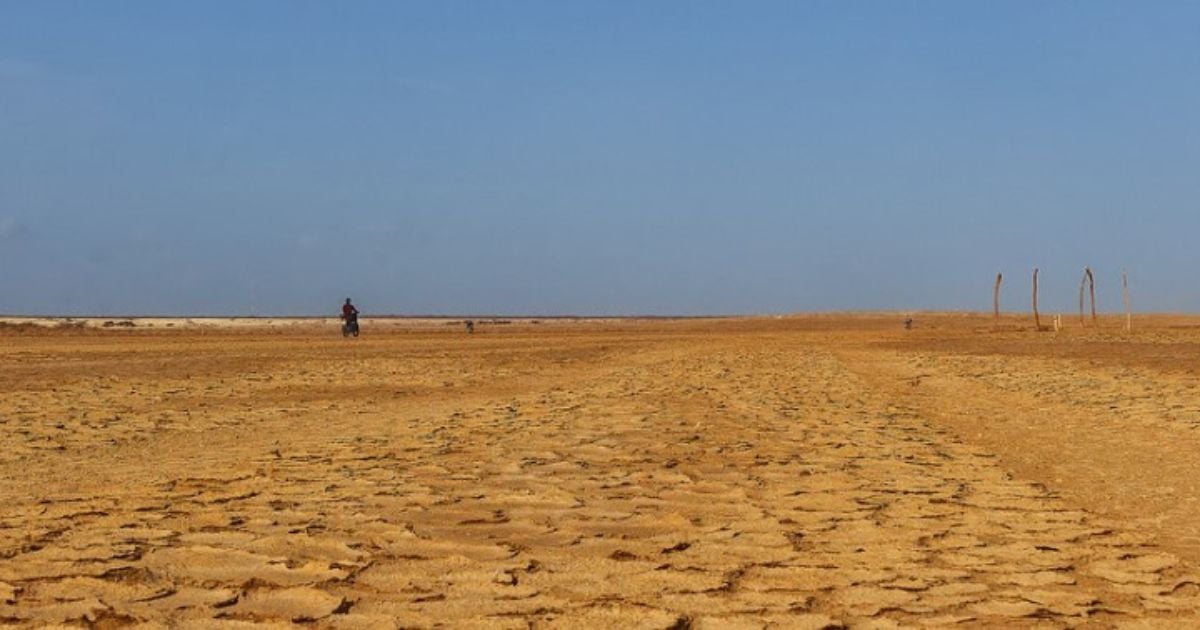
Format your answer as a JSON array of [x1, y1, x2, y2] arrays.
[[0, 0, 1200, 314]]
